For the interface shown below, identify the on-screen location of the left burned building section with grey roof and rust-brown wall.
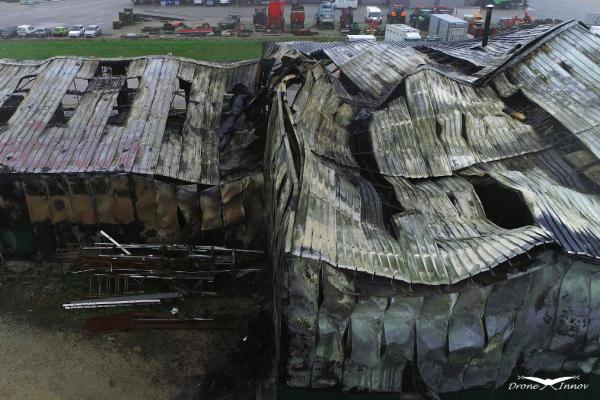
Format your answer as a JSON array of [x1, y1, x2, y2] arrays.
[[0, 56, 262, 245]]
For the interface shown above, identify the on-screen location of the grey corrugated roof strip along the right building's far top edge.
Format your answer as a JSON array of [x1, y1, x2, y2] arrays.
[[278, 22, 574, 102]]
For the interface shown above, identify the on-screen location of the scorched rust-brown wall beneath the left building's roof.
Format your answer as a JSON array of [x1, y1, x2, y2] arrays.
[[0, 173, 264, 252]]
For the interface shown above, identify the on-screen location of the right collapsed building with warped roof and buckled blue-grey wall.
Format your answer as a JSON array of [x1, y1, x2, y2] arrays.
[[265, 22, 600, 392]]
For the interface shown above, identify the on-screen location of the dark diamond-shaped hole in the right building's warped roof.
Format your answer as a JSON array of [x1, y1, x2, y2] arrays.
[[473, 182, 534, 229]]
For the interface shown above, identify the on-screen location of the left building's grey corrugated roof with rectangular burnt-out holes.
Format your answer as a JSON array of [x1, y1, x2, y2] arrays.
[[0, 57, 257, 184]]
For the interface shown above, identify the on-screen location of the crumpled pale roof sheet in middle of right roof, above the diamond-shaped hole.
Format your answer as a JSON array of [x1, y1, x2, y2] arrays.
[[370, 70, 547, 178]]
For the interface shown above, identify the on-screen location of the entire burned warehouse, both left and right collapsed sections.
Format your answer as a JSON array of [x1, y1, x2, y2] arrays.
[[0, 21, 600, 397]]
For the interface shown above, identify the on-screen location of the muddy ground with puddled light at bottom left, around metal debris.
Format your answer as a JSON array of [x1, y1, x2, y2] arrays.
[[0, 261, 268, 400]]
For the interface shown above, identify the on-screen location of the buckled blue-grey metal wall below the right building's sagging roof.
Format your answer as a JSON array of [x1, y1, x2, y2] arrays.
[[285, 252, 600, 393]]
